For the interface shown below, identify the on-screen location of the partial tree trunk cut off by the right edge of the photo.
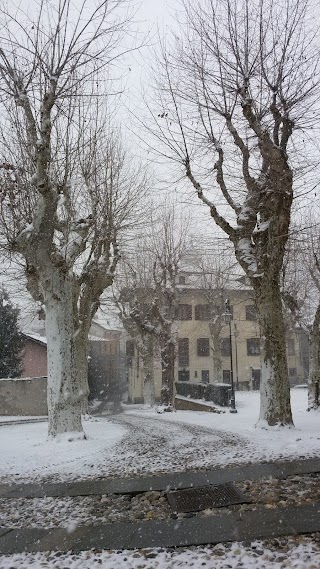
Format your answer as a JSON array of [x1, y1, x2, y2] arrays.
[[308, 304, 320, 411]]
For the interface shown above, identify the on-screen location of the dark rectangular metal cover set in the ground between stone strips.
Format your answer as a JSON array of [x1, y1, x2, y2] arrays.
[[167, 483, 248, 513]]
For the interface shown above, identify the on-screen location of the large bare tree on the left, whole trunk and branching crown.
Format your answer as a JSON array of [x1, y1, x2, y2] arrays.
[[0, 0, 146, 437]]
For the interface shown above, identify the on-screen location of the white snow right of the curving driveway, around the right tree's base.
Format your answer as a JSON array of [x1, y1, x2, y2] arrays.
[[126, 389, 320, 465]]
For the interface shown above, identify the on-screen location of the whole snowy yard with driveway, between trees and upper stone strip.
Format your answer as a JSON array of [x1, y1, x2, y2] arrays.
[[0, 389, 320, 482]]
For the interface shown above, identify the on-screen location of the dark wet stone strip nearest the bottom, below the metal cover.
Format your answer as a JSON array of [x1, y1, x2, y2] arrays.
[[0, 504, 320, 555]]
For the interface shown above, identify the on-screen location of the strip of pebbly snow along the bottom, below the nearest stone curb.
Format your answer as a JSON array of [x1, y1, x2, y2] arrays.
[[0, 538, 320, 569]]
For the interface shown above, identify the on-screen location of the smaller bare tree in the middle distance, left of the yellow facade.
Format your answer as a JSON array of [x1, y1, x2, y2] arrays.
[[116, 204, 189, 406]]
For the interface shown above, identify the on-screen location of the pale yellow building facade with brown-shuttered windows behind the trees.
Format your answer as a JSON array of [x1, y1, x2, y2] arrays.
[[126, 282, 308, 403]]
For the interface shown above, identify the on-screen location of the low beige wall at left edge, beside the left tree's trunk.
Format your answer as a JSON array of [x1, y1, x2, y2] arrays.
[[0, 377, 48, 415]]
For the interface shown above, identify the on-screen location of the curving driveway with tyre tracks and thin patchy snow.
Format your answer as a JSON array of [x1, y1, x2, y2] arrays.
[[101, 411, 249, 476]]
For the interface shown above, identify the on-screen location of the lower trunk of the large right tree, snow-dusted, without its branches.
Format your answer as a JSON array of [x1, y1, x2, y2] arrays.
[[255, 277, 293, 426]]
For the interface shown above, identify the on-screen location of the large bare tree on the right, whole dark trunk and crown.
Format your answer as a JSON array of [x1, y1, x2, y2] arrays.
[[150, 0, 319, 426]]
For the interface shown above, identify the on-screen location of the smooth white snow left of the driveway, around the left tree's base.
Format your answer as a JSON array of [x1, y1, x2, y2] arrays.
[[0, 418, 126, 483]]
